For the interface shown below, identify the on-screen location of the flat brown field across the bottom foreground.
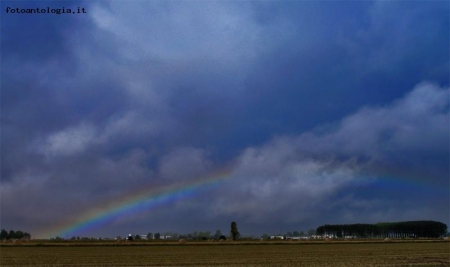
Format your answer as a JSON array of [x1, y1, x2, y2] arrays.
[[0, 242, 450, 266]]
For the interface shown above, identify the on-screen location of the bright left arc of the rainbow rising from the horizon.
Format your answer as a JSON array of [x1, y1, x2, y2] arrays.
[[37, 171, 229, 238]]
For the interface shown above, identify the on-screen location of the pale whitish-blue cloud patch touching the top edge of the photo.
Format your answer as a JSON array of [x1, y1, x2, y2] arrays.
[[91, 2, 259, 64]]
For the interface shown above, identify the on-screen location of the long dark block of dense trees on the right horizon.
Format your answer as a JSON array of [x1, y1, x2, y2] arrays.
[[317, 221, 447, 238]]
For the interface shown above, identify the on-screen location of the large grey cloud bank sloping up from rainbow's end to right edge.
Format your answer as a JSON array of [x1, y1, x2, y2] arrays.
[[203, 83, 450, 223]]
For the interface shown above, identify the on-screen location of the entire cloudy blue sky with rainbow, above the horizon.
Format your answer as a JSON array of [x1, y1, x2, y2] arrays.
[[0, 0, 450, 238]]
